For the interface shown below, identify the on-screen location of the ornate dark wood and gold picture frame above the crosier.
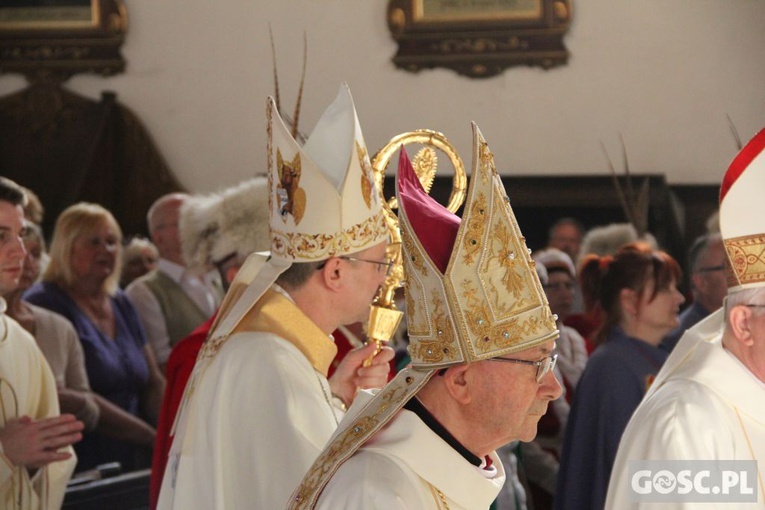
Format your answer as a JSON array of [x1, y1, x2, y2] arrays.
[[388, 0, 571, 78]]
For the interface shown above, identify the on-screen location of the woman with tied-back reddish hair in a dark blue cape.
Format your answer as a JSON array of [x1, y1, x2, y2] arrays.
[[555, 243, 685, 510]]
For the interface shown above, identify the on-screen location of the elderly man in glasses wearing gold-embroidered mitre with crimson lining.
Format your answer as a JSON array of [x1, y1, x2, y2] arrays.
[[289, 125, 561, 510]]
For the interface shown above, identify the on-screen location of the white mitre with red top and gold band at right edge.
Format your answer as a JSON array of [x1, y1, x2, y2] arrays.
[[720, 129, 765, 291]]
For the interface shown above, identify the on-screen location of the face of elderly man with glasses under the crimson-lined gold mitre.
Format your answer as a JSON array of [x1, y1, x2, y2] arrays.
[[476, 340, 561, 449]]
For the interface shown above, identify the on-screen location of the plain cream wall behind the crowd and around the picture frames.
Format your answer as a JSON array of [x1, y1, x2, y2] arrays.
[[0, 0, 765, 191]]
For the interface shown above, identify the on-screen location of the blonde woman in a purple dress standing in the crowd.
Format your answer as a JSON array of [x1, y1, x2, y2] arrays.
[[24, 203, 164, 470]]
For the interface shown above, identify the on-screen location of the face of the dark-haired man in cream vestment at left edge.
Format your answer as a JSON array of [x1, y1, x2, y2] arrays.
[[0, 200, 26, 295]]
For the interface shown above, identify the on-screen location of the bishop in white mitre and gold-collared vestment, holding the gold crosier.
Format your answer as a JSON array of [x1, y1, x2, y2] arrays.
[[158, 84, 393, 510]]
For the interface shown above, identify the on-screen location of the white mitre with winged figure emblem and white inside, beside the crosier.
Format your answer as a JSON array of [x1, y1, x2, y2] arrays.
[[268, 83, 388, 262]]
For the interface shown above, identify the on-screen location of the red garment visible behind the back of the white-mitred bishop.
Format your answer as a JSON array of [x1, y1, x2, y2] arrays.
[[149, 310, 218, 510]]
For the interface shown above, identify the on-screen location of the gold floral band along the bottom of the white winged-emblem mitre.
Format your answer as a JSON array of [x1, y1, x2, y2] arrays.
[[271, 210, 388, 260]]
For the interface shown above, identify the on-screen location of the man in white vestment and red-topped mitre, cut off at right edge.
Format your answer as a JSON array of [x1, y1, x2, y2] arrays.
[[606, 130, 765, 510]]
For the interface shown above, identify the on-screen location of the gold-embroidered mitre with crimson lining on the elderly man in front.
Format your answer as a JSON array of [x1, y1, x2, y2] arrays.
[[397, 124, 558, 368]]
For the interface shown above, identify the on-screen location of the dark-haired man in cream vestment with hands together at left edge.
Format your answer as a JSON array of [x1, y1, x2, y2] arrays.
[[0, 177, 83, 510]]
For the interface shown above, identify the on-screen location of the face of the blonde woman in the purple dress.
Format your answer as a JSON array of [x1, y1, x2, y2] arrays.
[[71, 220, 120, 282]]
